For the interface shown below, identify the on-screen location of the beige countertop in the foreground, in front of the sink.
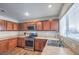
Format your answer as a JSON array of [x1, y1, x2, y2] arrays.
[[41, 40, 74, 55]]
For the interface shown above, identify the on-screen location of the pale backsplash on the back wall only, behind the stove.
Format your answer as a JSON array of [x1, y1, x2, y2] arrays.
[[19, 31, 58, 37]]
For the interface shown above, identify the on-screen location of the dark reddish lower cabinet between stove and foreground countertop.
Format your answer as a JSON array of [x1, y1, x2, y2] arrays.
[[35, 39, 47, 51]]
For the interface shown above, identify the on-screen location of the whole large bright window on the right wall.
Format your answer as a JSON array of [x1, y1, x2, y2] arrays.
[[60, 3, 79, 40]]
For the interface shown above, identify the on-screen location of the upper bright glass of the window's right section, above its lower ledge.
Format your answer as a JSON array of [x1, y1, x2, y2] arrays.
[[67, 4, 79, 34]]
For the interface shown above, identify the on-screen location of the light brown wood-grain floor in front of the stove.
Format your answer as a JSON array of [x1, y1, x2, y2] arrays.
[[1, 47, 41, 55]]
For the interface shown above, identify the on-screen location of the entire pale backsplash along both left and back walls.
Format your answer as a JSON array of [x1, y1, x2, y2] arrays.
[[0, 31, 58, 39]]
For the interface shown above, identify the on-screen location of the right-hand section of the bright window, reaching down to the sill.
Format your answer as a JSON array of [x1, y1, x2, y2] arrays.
[[67, 4, 79, 39]]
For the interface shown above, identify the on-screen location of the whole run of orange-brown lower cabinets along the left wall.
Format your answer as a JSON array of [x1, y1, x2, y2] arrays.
[[0, 38, 17, 54]]
